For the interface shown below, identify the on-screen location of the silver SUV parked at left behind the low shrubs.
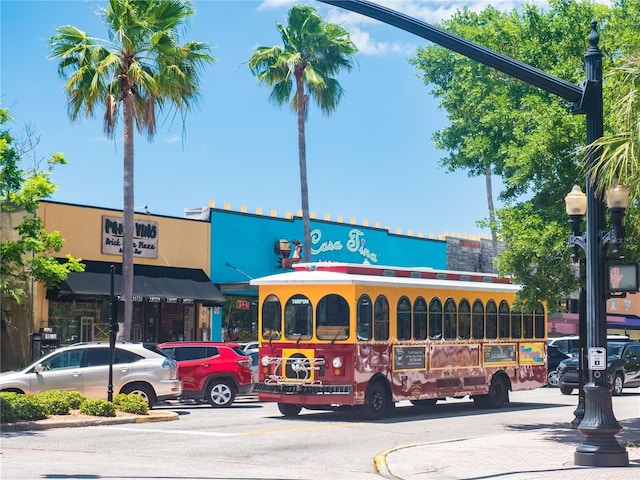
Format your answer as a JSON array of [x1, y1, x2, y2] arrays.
[[0, 342, 182, 408]]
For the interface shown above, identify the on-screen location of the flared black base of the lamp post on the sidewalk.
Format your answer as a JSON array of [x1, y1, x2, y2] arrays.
[[574, 383, 629, 467]]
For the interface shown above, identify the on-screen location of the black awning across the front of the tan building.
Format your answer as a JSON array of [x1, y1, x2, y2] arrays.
[[47, 261, 225, 305]]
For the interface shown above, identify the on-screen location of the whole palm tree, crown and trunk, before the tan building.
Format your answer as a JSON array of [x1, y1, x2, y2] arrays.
[[50, 0, 215, 340]]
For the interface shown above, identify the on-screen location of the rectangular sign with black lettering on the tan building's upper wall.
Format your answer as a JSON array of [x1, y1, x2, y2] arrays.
[[102, 215, 158, 258]]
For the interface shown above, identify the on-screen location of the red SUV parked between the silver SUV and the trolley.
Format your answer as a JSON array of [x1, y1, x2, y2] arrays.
[[158, 342, 253, 407]]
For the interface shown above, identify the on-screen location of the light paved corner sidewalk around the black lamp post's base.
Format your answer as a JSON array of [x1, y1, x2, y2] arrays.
[[374, 416, 640, 480]]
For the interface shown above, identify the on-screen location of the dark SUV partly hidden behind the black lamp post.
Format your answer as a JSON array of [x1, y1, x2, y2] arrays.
[[558, 341, 640, 395]]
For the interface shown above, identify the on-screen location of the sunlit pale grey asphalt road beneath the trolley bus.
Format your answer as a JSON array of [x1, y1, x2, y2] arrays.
[[0, 388, 640, 480]]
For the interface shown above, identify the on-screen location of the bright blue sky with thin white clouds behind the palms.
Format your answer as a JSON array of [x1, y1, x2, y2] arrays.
[[0, 0, 564, 240]]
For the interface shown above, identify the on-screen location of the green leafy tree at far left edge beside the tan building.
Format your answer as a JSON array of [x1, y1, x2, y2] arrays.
[[0, 109, 84, 363]]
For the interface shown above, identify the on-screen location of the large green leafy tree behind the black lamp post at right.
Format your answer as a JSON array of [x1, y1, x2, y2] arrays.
[[411, 0, 637, 309]]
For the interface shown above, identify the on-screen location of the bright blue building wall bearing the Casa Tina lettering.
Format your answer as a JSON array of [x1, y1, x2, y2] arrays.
[[210, 208, 447, 286]]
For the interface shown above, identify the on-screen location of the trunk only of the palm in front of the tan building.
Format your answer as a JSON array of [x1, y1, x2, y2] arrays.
[[119, 80, 134, 341]]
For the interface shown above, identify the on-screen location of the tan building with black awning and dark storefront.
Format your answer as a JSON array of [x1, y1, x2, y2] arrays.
[[2, 201, 224, 370]]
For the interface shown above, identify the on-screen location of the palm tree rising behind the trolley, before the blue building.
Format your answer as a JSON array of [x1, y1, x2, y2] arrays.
[[249, 5, 358, 262]]
